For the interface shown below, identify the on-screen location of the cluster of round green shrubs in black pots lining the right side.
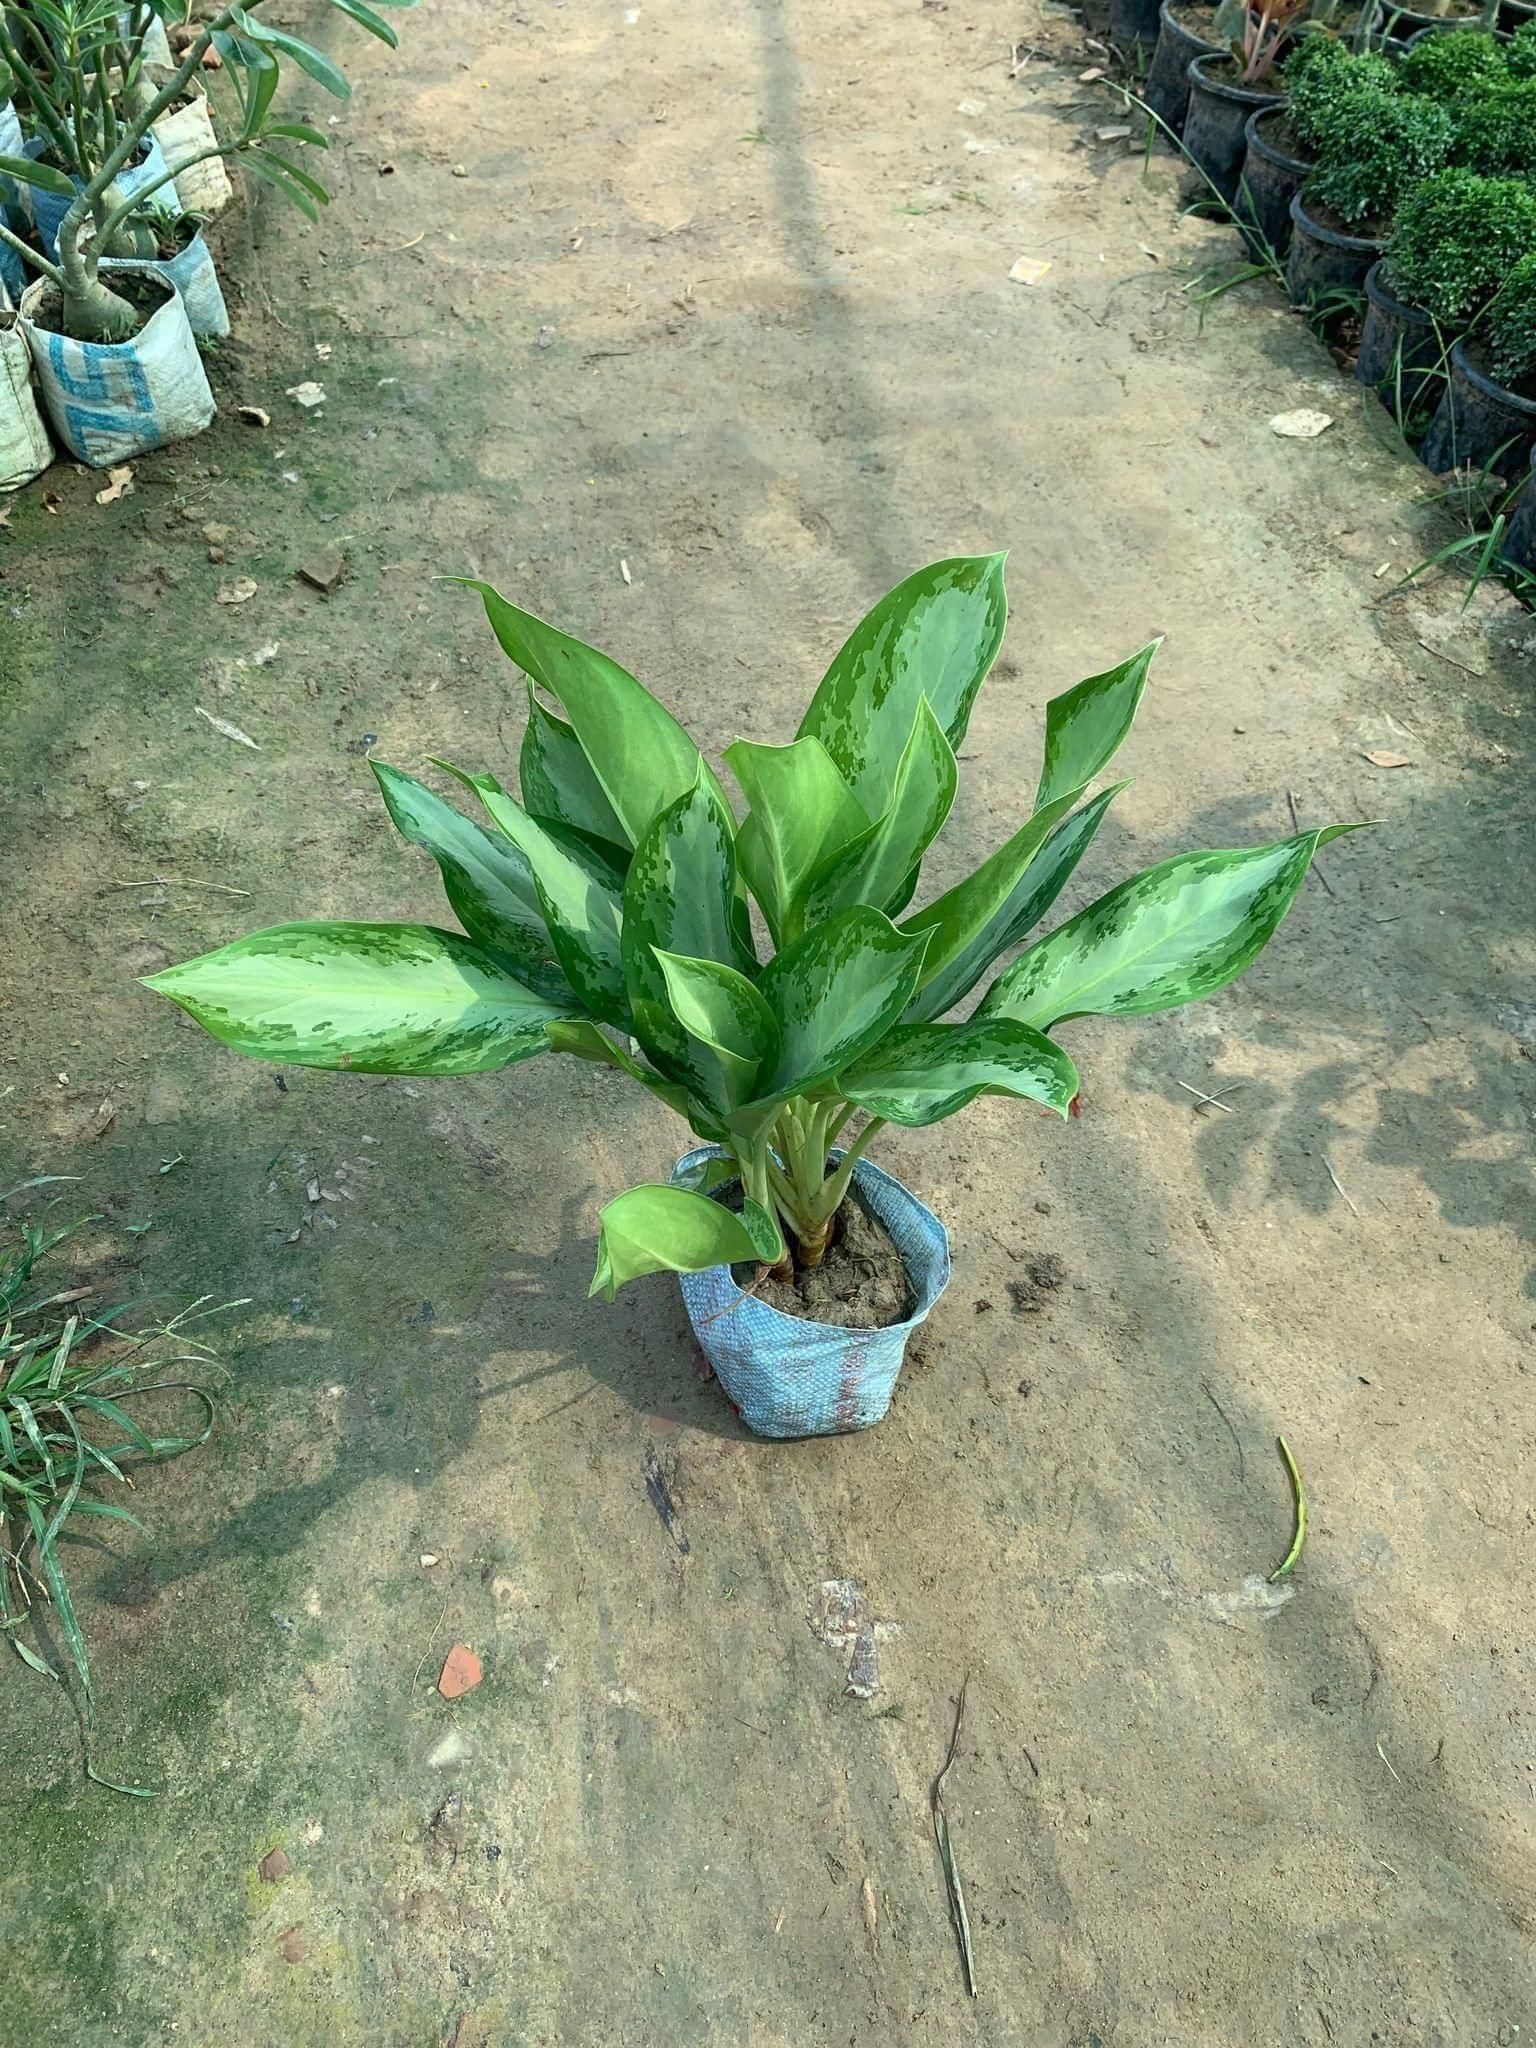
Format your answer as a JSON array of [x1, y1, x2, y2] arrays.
[[1143, 12, 1536, 569]]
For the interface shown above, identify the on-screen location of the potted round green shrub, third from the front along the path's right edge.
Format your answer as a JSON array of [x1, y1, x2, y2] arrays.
[[1286, 92, 1456, 305]]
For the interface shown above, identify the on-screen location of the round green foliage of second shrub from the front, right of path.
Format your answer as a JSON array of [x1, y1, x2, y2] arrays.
[[1386, 169, 1536, 328]]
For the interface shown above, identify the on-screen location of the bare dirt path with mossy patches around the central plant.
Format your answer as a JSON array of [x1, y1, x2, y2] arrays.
[[0, 0, 1536, 2048]]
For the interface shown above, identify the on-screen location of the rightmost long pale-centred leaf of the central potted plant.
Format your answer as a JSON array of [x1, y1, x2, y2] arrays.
[[977, 825, 1360, 1030]]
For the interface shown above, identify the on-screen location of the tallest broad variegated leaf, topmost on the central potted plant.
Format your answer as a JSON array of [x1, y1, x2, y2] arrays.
[[801, 555, 1008, 817]]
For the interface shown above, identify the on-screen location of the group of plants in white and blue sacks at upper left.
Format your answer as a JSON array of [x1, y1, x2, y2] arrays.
[[0, 0, 412, 489]]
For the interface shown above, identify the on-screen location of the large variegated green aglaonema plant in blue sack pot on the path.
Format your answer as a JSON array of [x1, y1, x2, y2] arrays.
[[138, 555, 1341, 1436]]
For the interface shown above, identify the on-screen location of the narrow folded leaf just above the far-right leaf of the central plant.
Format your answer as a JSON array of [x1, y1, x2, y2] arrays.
[[901, 782, 1126, 1022]]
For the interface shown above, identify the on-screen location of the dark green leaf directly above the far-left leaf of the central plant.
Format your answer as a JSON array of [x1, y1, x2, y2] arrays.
[[369, 762, 569, 995]]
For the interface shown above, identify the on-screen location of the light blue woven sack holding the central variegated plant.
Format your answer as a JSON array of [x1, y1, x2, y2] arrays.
[[672, 1145, 950, 1438]]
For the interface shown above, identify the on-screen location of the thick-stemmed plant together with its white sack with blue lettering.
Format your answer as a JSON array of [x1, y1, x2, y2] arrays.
[[0, 0, 409, 465]]
